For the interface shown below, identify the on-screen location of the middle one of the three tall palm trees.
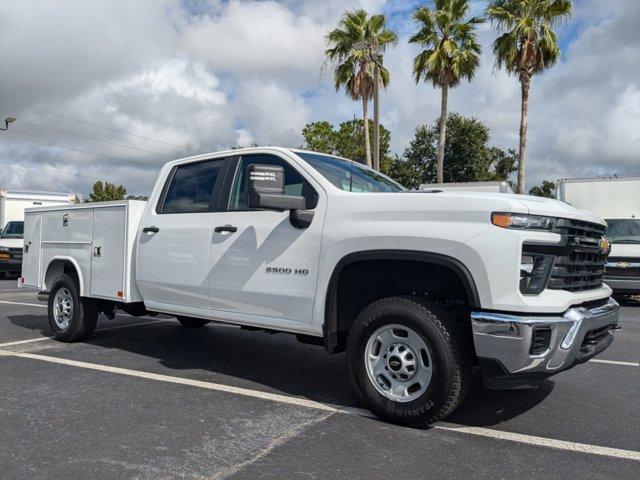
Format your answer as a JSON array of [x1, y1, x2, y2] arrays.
[[409, 0, 483, 183]]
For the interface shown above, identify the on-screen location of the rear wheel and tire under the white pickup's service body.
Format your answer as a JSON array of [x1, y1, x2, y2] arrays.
[[48, 275, 99, 342]]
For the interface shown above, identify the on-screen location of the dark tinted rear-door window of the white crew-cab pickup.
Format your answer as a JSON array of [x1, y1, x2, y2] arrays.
[[161, 160, 223, 213]]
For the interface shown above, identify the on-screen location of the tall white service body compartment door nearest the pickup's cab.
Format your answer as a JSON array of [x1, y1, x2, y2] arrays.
[[91, 206, 127, 298]]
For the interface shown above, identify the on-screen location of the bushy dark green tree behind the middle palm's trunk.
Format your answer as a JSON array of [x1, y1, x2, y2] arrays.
[[385, 113, 517, 188]]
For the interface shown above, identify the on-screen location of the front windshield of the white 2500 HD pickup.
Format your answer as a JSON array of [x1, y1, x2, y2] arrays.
[[296, 152, 405, 192]]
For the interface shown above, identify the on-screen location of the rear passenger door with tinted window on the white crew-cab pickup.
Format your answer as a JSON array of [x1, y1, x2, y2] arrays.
[[137, 158, 227, 309]]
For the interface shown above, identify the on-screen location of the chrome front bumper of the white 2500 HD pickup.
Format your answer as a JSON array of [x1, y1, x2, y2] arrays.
[[471, 298, 620, 388]]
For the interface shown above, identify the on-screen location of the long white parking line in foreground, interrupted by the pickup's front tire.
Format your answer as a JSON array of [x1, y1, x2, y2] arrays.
[[0, 350, 640, 461]]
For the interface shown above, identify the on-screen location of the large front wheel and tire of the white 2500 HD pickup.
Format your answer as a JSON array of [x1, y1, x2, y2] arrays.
[[347, 297, 471, 427]]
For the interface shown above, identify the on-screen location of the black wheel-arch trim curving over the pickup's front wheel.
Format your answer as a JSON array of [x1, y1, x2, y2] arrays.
[[322, 250, 480, 353]]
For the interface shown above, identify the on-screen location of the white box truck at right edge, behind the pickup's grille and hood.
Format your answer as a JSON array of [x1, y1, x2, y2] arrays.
[[557, 177, 640, 295]]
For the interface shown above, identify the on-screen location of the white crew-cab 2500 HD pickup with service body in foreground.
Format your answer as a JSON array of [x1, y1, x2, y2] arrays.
[[19, 147, 619, 426]]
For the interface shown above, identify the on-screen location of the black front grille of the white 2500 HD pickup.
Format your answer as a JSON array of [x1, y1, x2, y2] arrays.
[[547, 218, 607, 292]]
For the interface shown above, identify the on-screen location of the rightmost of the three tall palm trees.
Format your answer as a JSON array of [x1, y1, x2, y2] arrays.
[[487, 0, 573, 193]]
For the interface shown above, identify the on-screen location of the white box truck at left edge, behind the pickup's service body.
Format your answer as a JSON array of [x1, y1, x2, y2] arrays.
[[0, 190, 76, 278]]
